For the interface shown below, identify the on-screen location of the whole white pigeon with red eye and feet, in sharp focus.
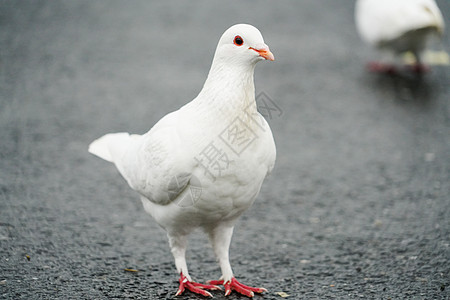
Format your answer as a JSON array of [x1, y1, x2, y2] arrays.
[[89, 24, 276, 297]]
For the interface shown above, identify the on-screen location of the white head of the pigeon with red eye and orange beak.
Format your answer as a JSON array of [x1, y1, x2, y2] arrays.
[[214, 24, 275, 64]]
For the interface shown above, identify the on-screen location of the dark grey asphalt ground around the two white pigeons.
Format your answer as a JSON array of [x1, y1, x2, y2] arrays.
[[0, 0, 450, 299]]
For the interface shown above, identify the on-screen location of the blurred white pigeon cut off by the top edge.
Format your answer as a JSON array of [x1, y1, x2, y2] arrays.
[[355, 0, 445, 72]]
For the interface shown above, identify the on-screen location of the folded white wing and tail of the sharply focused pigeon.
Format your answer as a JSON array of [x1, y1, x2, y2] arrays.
[[89, 111, 194, 205]]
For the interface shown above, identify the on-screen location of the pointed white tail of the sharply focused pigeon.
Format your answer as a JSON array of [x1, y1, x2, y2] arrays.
[[88, 132, 132, 163]]
